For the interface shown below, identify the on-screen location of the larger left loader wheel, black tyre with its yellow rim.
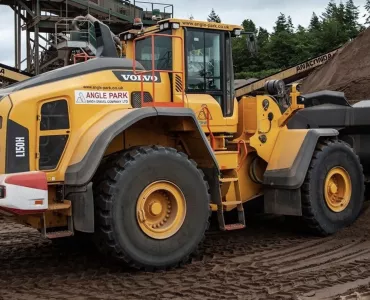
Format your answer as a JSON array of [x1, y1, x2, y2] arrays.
[[94, 146, 210, 271]]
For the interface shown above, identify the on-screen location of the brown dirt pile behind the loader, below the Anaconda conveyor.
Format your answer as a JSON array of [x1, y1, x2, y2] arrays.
[[302, 29, 370, 101]]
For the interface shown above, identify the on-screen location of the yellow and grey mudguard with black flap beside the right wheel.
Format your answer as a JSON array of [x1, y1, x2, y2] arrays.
[[263, 129, 339, 216]]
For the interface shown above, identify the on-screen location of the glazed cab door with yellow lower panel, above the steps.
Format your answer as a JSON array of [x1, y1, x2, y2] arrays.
[[185, 28, 233, 131]]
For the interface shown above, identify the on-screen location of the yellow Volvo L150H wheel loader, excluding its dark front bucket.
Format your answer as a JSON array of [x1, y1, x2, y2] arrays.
[[0, 19, 364, 270]]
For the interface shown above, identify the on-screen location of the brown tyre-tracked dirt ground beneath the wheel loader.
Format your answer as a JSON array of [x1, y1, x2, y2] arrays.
[[0, 203, 370, 300]]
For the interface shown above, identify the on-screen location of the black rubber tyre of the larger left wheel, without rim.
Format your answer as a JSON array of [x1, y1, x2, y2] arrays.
[[94, 146, 210, 271]]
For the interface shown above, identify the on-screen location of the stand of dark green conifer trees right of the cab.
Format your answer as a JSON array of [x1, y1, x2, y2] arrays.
[[233, 0, 362, 78]]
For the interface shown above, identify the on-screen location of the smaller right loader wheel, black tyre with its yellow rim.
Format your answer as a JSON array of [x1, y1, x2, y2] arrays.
[[302, 141, 365, 235]]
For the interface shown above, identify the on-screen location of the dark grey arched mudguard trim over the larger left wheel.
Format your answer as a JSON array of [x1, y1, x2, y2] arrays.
[[64, 107, 219, 186]]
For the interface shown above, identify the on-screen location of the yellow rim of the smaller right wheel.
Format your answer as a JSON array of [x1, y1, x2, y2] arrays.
[[324, 167, 352, 213]]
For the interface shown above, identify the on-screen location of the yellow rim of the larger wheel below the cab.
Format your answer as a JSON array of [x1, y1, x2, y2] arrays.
[[136, 181, 186, 240]]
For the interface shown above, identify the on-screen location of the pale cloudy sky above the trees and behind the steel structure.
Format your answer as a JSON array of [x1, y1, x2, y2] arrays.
[[0, 0, 366, 66]]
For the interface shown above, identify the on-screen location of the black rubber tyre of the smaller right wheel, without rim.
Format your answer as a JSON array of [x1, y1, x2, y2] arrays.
[[302, 140, 365, 236]]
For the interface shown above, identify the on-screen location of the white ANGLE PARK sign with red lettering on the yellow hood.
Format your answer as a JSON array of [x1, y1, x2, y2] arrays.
[[75, 91, 129, 104]]
